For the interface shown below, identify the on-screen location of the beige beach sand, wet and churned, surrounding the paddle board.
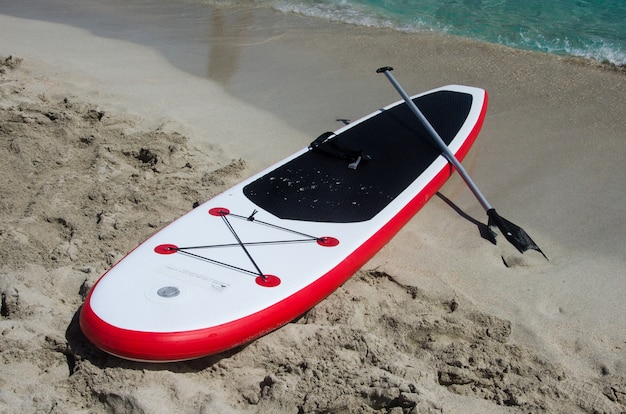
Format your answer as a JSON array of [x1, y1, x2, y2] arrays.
[[0, 1, 626, 413]]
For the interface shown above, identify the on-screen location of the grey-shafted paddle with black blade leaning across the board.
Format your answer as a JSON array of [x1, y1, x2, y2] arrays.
[[376, 66, 548, 259]]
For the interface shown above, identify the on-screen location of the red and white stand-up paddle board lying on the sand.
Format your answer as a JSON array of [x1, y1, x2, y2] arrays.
[[80, 85, 487, 362]]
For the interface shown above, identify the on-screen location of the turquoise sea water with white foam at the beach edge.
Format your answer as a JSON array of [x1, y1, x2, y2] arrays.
[[262, 0, 626, 65]]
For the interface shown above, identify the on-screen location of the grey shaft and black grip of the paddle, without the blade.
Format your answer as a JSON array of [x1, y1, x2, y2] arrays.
[[376, 66, 493, 212]]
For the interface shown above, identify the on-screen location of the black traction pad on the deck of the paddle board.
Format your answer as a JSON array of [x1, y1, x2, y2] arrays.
[[243, 90, 472, 223]]
